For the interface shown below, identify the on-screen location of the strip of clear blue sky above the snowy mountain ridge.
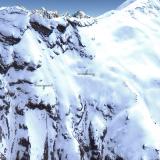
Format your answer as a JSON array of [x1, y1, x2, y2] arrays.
[[0, 0, 125, 16]]
